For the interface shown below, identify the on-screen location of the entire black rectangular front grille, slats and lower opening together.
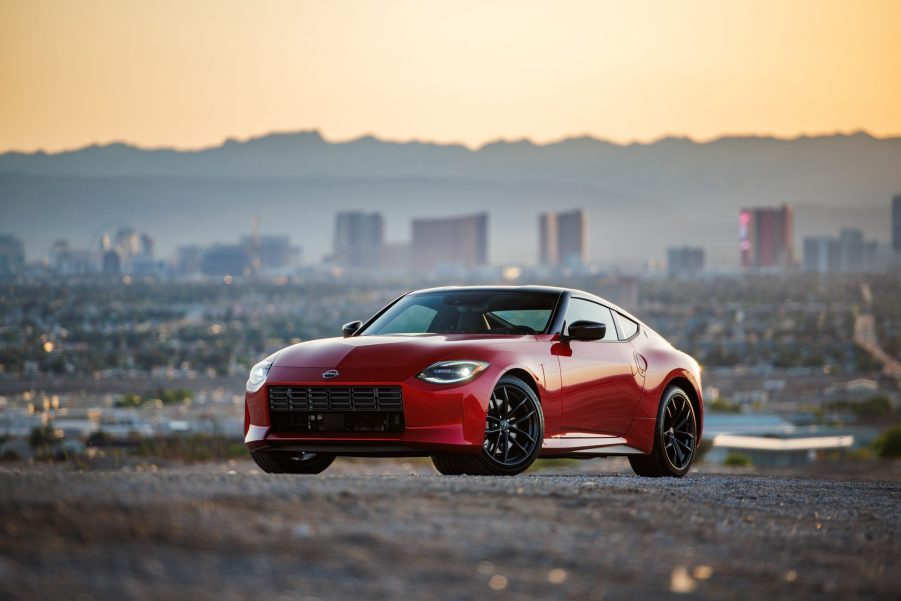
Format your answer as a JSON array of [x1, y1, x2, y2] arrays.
[[269, 386, 404, 432]]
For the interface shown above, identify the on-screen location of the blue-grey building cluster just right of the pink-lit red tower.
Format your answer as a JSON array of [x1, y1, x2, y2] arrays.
[[804, 229, 877, 273]]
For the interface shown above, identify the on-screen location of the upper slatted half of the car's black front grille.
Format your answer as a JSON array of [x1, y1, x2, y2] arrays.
[[269, 386, 404, 411]]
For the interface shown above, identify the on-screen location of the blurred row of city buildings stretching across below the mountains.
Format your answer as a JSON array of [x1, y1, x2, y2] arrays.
[[7, 196, 901, 280]]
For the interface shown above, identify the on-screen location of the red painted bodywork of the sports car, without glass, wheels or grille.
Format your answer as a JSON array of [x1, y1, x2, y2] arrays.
[[244, 290, 703, 456]]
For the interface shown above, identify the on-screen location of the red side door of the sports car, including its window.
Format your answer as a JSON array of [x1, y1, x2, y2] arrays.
[[556, 297, 644, 436]]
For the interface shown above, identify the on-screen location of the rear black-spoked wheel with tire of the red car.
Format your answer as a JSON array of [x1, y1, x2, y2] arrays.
[[629, 386, 698, 478]]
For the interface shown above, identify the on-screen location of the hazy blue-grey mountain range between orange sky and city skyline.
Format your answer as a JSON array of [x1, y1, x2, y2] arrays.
[[0, 132, 901, 267]]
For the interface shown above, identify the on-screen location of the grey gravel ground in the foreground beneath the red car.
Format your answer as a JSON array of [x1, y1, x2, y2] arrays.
[[0, 460, 901, 600]]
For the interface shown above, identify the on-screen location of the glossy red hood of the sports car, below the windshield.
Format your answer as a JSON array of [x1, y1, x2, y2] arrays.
[[273, 334, 535, 379]]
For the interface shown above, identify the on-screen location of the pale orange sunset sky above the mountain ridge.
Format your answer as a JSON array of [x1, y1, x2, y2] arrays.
[[0, 0, 901, 152]]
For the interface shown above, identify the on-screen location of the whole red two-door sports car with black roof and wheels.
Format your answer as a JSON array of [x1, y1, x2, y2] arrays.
[[244, 286, 704, 476]]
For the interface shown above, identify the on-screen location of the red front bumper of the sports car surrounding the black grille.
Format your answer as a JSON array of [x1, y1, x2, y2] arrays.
[[244, 368, 498, 456]]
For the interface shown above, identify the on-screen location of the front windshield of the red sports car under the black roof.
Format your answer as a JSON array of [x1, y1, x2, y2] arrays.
[[361, 290, 558, 336]]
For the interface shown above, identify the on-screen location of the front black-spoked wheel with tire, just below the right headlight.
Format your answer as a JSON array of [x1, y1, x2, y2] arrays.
[[432, 376, 544, 476]]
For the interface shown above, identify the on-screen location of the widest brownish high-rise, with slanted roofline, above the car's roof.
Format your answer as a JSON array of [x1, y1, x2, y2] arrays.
[[410, 213, 488, 270]]
